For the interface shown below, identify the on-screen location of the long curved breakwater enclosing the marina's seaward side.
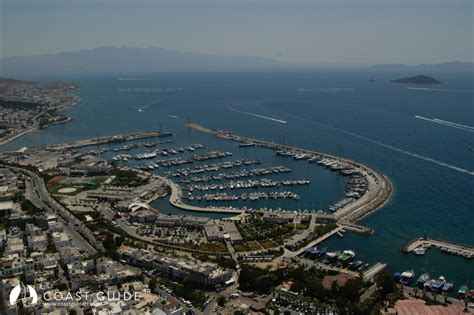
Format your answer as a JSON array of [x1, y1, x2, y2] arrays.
[[186, 123, 392, 226]]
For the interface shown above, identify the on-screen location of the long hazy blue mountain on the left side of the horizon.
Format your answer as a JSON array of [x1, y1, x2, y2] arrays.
[[0, 47, 286, 76]]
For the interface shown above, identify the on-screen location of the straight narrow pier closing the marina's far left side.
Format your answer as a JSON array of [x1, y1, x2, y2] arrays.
[[38, 131, 172, 150]]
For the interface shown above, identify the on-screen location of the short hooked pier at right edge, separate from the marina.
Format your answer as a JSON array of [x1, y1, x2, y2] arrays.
[[402, 237, 474, 259]]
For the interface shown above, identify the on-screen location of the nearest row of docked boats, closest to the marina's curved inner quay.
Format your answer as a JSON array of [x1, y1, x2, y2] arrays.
[[187, 191, 300, 201]]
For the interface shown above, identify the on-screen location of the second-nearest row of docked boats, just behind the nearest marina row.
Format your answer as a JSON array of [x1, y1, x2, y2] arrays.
[[188, 178, 310, 191]]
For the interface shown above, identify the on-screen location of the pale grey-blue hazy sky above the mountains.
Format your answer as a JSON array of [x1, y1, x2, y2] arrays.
[[0, 0, 474, 64]]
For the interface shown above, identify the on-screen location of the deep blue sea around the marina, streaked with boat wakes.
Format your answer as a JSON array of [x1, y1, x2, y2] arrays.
[[2, 70, 474, 290]]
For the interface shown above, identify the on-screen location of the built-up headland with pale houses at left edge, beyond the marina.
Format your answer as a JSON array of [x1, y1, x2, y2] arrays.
[[0, 78, 81, 145]]
